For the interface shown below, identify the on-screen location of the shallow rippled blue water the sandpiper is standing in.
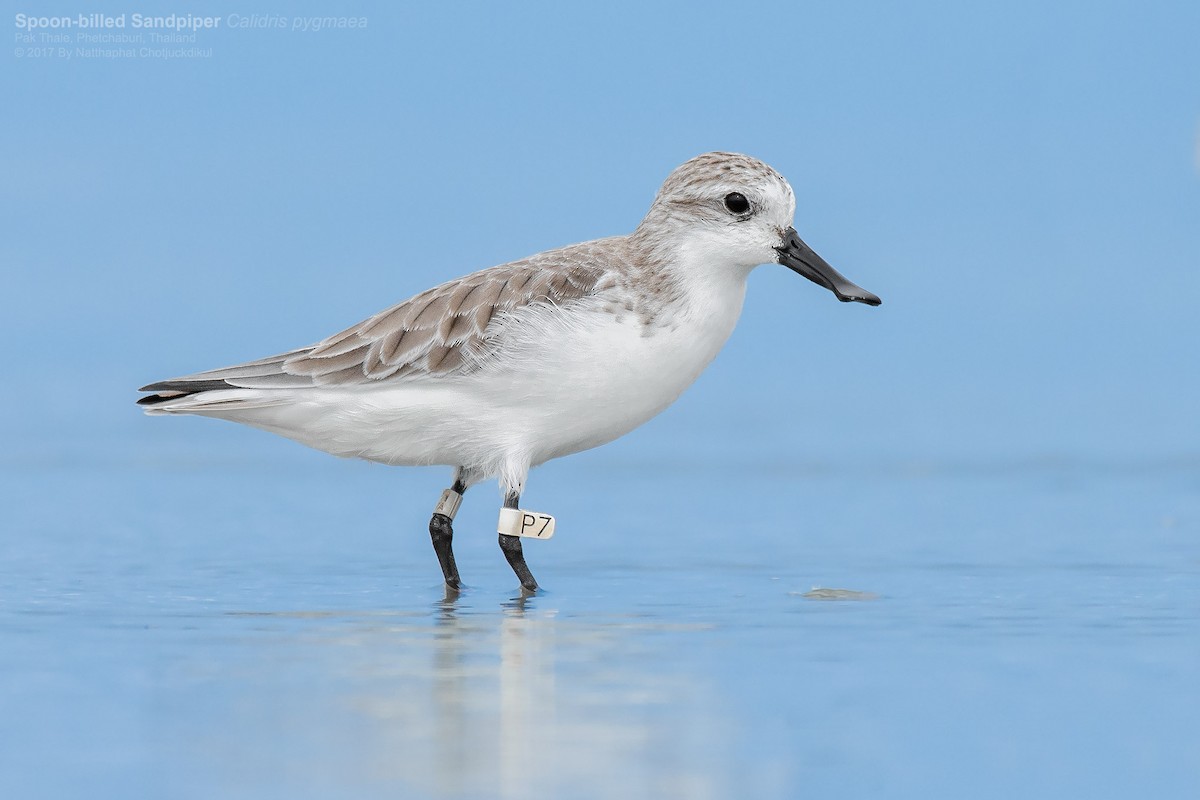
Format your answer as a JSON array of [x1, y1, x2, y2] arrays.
[[0, 439, 1200, 799]]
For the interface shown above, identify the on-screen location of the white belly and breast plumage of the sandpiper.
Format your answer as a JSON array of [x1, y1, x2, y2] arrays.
[[291, 287, 742, 475]]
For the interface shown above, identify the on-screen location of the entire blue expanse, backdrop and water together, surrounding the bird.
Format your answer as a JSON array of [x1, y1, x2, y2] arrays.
[[0, 1, 1200, 796]]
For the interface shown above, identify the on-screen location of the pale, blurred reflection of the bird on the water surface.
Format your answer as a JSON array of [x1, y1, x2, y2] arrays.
[[208, 590, 734, 798]]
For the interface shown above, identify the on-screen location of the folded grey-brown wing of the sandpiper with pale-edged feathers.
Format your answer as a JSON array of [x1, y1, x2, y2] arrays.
[[142, 240, 614, 404]]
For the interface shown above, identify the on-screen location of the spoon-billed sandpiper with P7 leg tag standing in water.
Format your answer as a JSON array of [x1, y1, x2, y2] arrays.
[[138, 152, 881, 594]]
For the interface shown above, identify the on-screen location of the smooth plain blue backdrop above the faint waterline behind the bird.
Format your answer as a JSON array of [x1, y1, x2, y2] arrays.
[[0, 2, 1200, 459]]
